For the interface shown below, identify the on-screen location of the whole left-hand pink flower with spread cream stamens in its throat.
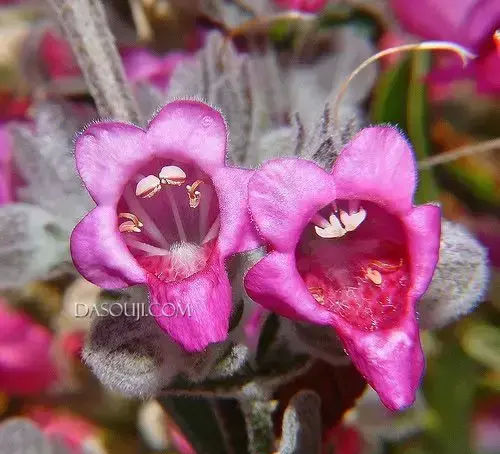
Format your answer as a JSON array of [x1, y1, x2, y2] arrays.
[[71, 101, 259, 351]]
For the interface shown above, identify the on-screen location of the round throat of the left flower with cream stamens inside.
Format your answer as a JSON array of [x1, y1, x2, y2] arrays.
[[117, 159, 220, 282]]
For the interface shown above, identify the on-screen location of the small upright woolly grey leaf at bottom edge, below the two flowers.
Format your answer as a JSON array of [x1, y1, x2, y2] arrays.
[[278, 391, 321, 454]]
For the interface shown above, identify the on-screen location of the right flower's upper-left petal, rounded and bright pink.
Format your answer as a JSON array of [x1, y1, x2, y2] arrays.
[[248, 158, 335, 251]]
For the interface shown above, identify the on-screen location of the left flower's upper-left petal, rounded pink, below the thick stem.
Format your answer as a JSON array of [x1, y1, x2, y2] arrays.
[[75, 122, 147, 204]]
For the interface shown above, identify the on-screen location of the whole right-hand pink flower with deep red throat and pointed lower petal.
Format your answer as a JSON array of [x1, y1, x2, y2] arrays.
[[245, 127, 440, 409]]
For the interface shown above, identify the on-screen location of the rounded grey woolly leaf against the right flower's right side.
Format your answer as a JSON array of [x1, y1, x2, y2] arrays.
[[419, 220, 490, 328]]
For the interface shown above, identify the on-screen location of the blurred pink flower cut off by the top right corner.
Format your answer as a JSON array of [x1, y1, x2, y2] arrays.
[[391, 0, 500, 94]]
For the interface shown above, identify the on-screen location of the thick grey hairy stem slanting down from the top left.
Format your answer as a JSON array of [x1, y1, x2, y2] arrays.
[[45, 0, 142, 124]]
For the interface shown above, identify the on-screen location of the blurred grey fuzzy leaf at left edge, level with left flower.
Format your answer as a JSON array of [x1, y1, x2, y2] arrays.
[[0, 203, 69, 288]]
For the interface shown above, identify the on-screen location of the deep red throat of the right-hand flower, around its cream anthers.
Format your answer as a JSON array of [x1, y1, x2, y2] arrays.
[[296, 201, 410, 331]]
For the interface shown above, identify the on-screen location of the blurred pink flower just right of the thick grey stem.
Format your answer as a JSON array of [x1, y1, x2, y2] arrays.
[[121, 48, 189, 91]]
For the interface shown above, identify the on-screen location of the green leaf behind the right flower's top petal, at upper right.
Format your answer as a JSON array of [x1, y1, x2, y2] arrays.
[[371, 52, 439, 203]]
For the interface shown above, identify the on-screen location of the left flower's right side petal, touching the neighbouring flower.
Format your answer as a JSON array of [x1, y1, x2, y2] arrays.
[[212, 167, 262, 257]]
